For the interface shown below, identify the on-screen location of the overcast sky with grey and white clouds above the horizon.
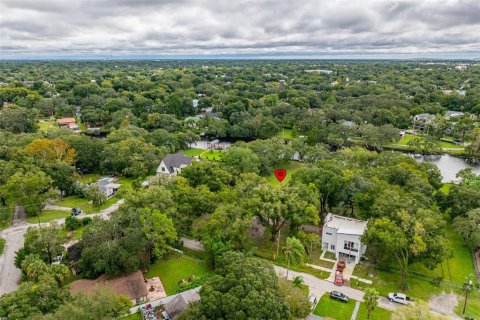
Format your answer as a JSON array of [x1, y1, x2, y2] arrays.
[[0, 0, 480, 59]]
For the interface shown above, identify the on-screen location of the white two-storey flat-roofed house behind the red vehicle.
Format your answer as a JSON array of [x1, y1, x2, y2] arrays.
[[322, 213, 367, 263]]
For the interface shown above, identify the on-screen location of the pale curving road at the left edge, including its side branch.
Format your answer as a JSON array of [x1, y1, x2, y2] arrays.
[[0, 199, 124, 296]]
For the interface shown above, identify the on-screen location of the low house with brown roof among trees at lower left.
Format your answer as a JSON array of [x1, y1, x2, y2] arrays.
[[69, 270, 148, 304]]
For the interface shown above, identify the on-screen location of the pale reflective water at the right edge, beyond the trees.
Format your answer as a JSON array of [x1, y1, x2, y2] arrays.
[[411, 154, 480, 182]]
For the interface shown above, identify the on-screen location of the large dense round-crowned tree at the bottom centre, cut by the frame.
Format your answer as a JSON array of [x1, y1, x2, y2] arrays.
[[182, 252, 290, 320]]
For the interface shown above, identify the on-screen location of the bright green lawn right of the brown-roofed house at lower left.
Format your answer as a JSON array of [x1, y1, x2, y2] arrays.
[[145, 254, 211, 295]]
